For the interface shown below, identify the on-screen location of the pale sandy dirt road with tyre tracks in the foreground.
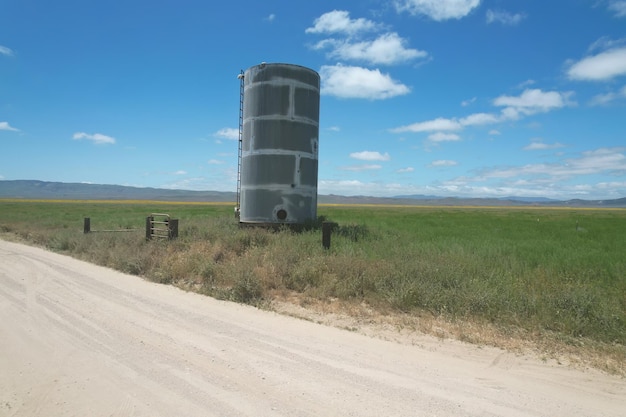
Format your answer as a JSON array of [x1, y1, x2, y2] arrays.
[[0, 237, 626, 417]]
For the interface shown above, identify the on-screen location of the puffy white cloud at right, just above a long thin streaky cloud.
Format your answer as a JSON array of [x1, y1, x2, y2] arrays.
[[493, 89, 575, 120]]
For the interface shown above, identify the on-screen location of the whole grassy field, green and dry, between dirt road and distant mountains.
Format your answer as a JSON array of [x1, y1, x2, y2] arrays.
[[0, 200, 626, 375]]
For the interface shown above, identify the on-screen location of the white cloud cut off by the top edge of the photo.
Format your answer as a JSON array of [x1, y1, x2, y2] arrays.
[[395, 0, 480, 21]]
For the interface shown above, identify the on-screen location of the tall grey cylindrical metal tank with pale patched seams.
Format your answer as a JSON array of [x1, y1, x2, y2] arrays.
[[239, 63, 320, 225]]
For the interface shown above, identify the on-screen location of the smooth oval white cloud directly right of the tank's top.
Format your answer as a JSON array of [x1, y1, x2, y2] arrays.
[[320, 64, 410, 100]]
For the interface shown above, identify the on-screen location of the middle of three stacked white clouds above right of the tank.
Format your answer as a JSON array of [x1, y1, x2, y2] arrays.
[[315, 32, 428, 65]]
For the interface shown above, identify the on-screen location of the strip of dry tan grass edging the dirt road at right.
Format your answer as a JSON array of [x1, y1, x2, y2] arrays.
[[268, 293, 626, 377]]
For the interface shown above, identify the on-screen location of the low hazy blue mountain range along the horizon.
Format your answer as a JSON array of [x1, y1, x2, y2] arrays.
[[0, 180, 626, 208]]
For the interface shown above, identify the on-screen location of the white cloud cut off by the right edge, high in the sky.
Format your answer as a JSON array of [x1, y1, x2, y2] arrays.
[[567, 47, 626, 81]]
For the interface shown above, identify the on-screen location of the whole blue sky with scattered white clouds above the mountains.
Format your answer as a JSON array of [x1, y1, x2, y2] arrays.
[[0, 0, 626, 199]]
